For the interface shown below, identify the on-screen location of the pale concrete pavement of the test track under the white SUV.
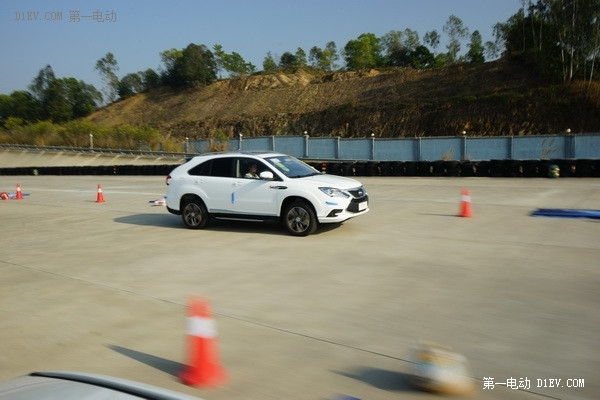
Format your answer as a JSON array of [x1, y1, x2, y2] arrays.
[[0, 176, 600, 400]]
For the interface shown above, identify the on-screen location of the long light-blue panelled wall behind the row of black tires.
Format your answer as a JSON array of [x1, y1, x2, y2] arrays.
[[198, 133, 600, 161]]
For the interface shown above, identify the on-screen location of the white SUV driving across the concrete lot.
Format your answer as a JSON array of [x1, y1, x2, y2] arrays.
[[166, 152, 369, 236]]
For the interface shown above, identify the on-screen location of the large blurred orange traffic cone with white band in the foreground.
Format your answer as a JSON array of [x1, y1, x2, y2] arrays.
[[179, 298, 226, 386]]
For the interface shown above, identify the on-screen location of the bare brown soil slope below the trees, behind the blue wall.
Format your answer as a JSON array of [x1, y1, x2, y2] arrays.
[[89, 61, 600, 139]]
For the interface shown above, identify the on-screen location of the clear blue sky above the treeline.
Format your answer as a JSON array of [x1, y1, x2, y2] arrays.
[[0, 0, 521, 94]]
